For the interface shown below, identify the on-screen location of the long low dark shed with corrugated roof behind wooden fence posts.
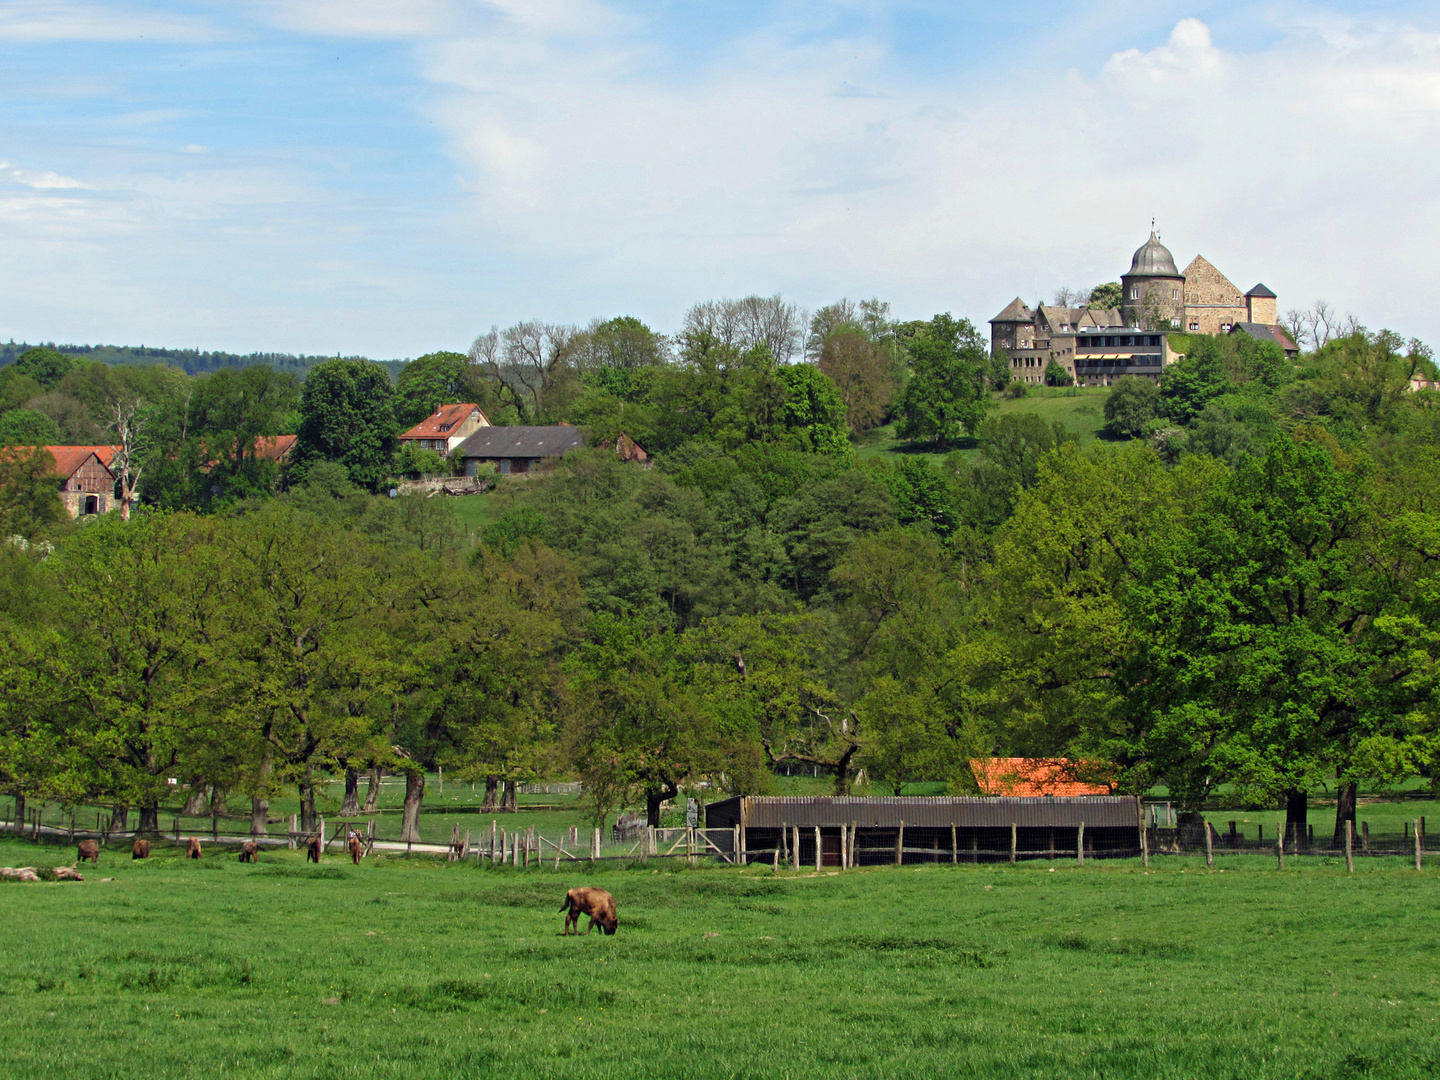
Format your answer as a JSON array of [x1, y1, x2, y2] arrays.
[[706, 795, 1142, 867]]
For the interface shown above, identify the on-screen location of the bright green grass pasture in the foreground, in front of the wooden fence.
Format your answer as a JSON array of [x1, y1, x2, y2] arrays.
[[0, 841, 1440, 1079]]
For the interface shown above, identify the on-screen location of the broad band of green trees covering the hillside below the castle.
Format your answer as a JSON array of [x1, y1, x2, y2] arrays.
[[0, 298, 1440, 832]]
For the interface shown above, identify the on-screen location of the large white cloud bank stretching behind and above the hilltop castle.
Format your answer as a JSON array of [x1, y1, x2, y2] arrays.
[[411, 11, 1440, 336]]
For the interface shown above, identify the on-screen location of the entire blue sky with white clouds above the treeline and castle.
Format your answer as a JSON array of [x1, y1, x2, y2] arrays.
[[0, 0, 1440, 359]]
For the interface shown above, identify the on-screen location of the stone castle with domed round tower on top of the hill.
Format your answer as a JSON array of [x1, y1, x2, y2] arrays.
[[989, 229, 1299, 386]]
